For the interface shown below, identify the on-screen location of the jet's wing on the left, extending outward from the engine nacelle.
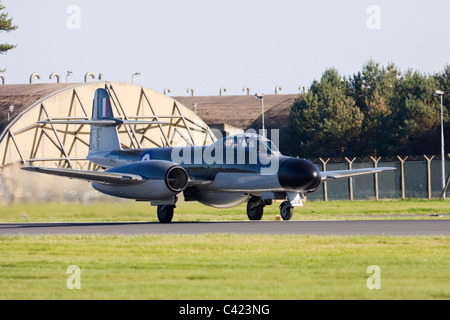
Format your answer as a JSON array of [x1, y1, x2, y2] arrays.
[[22, 167, 144, 185]]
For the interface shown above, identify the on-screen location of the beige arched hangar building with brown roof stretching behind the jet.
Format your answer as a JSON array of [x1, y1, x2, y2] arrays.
[[0, 81, 297, 203]]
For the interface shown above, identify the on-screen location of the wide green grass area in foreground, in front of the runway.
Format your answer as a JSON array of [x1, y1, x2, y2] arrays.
[[0, 235, 450, 300]]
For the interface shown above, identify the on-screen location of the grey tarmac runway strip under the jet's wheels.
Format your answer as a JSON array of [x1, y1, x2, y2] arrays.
[[0, 220, 450, 236]]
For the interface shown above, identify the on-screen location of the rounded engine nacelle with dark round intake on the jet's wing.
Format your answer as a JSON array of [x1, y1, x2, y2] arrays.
[[92, 160, 188, 201]]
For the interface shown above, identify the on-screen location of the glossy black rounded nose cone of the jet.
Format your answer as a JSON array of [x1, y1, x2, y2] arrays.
[[278, 158, 322, 191]]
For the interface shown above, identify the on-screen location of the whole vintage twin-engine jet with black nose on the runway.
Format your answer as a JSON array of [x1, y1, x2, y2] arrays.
[[22, 89, 395, 223]]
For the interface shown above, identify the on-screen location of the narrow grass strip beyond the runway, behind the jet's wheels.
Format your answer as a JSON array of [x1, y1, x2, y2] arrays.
[[0, 199, 450, 222]]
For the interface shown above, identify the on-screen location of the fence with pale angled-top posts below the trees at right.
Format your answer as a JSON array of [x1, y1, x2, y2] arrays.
[[308, 156, 450, 201]]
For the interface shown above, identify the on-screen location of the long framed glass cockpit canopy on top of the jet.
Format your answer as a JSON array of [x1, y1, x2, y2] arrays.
[[212, 133, 281, 156]]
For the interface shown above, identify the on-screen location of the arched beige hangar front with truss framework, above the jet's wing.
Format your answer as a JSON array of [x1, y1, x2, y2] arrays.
[[0, 82, 215, 169]]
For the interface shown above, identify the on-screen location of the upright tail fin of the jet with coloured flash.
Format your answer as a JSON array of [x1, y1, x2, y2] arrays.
[[89, 89, 121, 154]]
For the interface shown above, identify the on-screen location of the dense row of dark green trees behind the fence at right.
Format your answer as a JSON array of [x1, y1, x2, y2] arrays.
[[281, 60, 450, 158]]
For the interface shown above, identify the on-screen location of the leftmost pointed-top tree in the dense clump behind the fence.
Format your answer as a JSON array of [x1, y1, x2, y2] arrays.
[[290, 69, 364, 157]]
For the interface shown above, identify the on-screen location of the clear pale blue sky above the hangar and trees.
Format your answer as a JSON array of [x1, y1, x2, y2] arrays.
[[0, 0, 450, 96]]
